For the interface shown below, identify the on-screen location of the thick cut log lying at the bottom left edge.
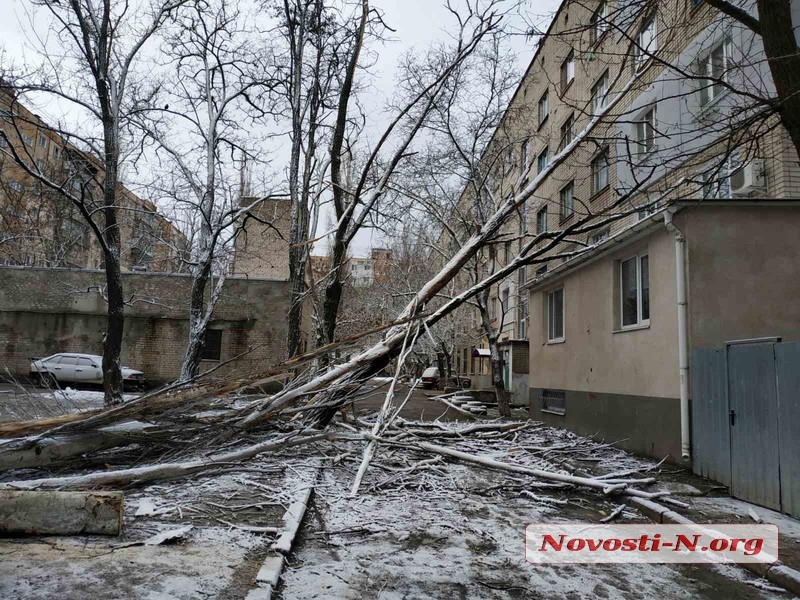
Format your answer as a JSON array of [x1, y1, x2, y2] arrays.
[[0, 490, 124, 536]]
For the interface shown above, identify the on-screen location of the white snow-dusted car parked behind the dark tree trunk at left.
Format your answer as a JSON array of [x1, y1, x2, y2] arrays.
[[30, 353, 146, 389]]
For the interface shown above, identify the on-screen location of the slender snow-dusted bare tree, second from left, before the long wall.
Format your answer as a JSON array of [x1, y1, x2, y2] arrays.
[[137, 0, 282, 381]]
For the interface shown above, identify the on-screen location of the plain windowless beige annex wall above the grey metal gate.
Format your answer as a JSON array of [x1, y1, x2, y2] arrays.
[[682, 204, 800, 348]]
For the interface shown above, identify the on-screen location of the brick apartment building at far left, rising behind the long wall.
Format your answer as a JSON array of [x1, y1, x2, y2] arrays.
[[0, 87, 187, 272]]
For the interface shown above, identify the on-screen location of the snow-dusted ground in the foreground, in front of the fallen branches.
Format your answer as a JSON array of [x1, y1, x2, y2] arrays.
[[0, 423, 800, 600]]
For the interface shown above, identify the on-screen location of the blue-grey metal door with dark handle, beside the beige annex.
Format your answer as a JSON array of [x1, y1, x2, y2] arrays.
[[728, 344, 781, 510]]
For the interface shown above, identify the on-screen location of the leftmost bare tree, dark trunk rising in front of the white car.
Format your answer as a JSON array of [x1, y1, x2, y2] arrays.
[[0, 0, 186, 404]]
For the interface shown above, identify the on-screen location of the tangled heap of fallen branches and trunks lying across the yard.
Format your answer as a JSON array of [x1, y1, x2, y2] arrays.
[[0, 328, 674, 520]]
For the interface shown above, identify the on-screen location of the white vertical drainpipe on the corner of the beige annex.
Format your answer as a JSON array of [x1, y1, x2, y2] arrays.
[[664, 210, 692, 460]]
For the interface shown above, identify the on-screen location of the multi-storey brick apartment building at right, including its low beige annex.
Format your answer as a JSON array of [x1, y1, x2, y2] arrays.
[[456, 0, 800, 461]]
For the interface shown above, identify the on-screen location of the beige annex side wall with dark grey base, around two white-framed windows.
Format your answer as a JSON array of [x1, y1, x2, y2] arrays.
[[529, 227, 680, 457]]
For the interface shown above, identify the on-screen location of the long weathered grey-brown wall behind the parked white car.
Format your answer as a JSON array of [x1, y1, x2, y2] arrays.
[[0, 267, 290, 381]]
